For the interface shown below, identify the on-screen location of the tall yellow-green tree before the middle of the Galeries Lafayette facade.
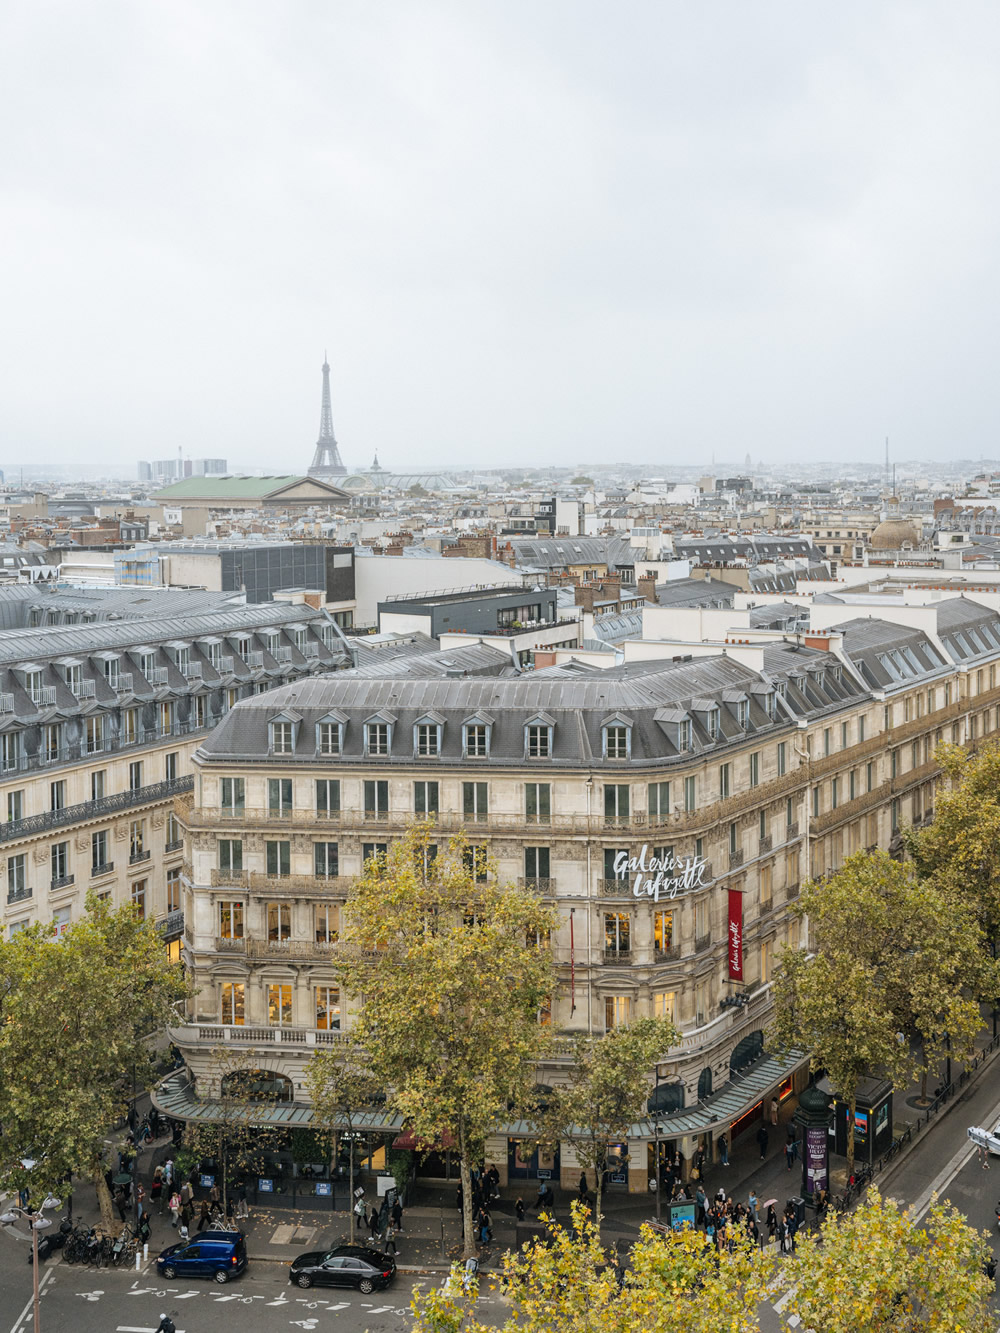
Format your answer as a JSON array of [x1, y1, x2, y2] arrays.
[[335, 824, 555, 1256]]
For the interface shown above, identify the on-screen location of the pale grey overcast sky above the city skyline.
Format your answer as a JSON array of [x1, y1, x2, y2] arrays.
[[0, 0, 1000, 472]]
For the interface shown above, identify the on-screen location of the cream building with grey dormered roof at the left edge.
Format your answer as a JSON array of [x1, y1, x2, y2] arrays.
[[0, 589, 349, 957]]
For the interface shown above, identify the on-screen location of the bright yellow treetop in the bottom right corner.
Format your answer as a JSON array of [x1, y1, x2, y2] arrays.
[[783, 1188, 996, 1333]]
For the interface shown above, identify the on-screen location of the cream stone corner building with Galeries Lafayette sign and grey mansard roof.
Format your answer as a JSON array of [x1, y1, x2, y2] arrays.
[[160, 599, 1000, 1190]]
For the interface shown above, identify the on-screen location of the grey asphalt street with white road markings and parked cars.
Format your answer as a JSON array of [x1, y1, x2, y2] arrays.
[[0, 1065, 1000, 1333]]
